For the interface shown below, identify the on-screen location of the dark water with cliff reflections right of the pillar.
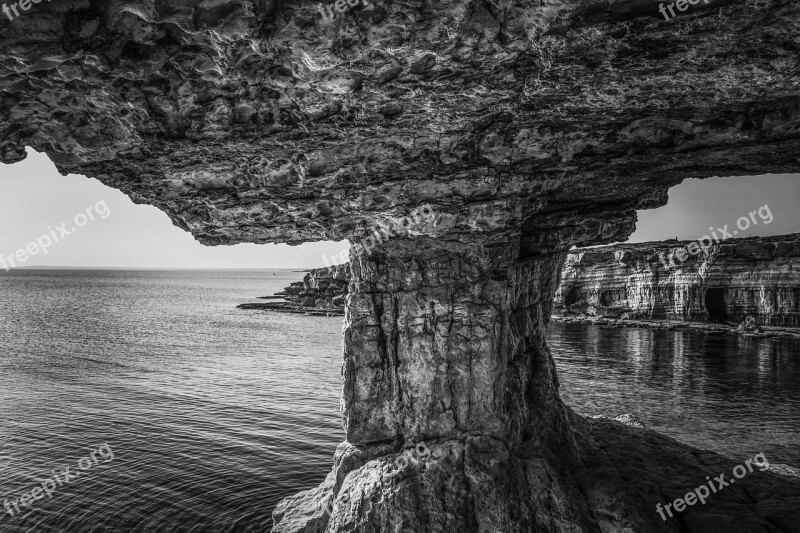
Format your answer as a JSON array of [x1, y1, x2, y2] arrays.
[[549, 323, 800, 466]]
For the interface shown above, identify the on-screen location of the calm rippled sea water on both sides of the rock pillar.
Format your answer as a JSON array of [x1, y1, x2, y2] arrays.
[[0, 271, 800, 533]]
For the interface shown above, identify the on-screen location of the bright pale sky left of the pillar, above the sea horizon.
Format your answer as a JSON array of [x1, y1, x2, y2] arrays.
[[0, 148, 350, 269]]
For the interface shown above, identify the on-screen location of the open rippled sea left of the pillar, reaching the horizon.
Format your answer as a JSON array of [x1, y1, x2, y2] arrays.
[[0, 271, 344, 533]]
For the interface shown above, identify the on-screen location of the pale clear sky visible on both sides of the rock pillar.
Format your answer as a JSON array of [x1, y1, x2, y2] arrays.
[[0, 149, 800, 269]]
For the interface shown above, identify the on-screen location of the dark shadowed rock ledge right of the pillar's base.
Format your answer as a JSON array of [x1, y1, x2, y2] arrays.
[[572, 415, 800, 533]]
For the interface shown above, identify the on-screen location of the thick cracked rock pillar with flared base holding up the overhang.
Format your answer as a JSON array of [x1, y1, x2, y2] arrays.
[[275, 237, 594, 533]]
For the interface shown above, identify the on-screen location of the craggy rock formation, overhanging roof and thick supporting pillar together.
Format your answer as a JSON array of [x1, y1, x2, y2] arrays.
[[0, 0, 800, 533]]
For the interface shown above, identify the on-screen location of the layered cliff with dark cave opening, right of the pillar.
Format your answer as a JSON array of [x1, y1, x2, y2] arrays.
[[555, 235, 800, 328]]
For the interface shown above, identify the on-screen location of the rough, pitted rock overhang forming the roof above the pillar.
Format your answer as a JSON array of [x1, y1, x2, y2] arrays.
[[0, 0, 800, 248]]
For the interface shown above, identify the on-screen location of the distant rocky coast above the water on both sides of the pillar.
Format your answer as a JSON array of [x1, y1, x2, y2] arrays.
[[238, 234, 800, 339]]
